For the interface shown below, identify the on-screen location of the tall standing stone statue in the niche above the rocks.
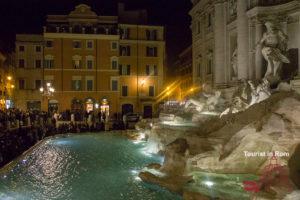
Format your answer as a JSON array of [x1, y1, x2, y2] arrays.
[[259, 21, 290, 77]]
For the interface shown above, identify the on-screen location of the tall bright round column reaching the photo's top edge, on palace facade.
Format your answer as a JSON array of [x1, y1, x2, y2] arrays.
[[237, 0, 249, 79]]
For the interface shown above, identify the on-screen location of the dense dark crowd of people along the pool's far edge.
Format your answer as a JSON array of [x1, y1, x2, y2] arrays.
[[0, 109, 135, 167]]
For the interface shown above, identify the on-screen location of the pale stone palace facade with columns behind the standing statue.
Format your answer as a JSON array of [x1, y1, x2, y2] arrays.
[[190, 0, 300, 88]]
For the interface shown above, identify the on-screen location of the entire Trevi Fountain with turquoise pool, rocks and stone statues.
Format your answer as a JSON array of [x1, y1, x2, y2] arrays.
[[0, 22, 300, 200]]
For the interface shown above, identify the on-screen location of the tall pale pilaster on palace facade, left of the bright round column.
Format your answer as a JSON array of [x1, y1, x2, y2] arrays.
[[213, 3, 226, 86]]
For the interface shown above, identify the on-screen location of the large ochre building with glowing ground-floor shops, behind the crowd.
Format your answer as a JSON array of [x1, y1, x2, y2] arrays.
[[14, 4, 165, 117]]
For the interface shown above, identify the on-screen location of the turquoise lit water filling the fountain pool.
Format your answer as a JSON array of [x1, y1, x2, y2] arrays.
[[0, 134, 181, 200]]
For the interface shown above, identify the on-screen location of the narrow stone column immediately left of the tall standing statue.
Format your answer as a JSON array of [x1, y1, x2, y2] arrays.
[[255, 20, 264, 80]]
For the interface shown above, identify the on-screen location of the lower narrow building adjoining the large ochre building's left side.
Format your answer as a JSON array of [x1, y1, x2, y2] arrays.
[[14, 34, 44, 110]]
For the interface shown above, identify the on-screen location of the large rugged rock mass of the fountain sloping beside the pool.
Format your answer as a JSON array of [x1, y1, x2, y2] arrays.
[[140, 92, 300, 199]]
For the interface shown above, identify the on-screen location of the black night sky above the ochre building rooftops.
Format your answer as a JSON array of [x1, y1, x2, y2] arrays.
[[0, 0, 191, 72]]
